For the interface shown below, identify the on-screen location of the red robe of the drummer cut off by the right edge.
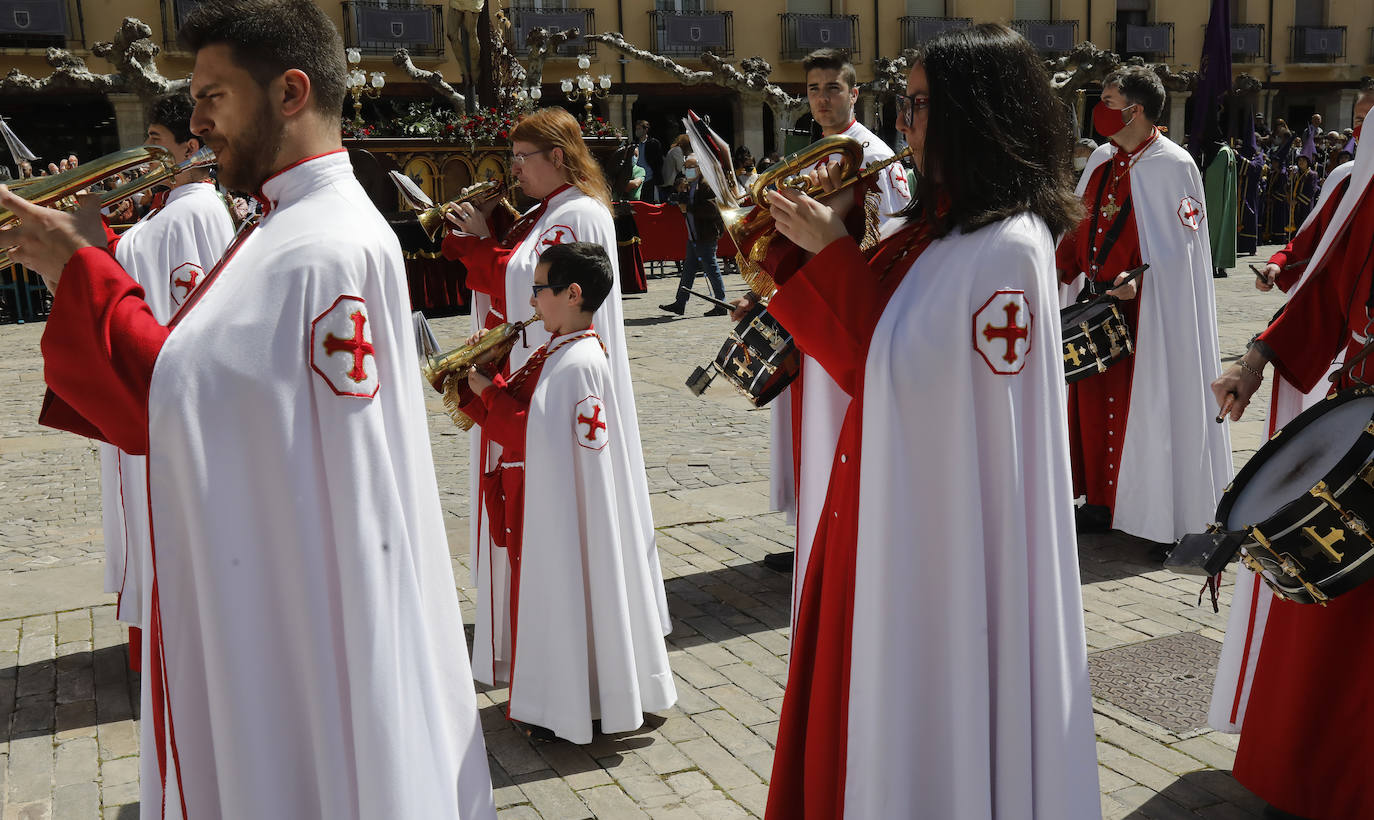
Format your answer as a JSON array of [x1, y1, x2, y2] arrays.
[[1234, 174, 1374, 820]]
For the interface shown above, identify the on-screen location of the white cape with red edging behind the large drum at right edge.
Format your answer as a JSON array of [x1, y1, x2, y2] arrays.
[[1208, 140, 1374, 733]]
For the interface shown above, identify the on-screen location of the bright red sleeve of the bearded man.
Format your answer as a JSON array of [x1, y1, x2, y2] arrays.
[[38, 247, 170, 455]]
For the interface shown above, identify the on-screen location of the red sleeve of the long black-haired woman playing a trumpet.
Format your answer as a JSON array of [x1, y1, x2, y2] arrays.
[[768, 236, 886, 396]]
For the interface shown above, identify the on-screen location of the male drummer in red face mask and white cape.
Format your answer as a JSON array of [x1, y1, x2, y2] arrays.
[[1057, 67, 1231, 543]]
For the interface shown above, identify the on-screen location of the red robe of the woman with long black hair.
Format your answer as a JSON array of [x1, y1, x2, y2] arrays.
[[765, 221, 925, 820]]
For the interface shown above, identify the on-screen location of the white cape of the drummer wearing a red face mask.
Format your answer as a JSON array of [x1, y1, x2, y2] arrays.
[[1059, 136, 1231, 543]]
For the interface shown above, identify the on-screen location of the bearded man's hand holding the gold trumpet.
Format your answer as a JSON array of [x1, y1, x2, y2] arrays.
[[0, 185, 104, 293]]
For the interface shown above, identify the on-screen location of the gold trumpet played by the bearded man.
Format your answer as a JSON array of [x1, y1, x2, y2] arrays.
[[0, 146, 216, 266]]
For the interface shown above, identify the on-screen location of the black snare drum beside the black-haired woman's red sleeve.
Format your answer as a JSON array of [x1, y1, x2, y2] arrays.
[[687, 305, 801, 407]]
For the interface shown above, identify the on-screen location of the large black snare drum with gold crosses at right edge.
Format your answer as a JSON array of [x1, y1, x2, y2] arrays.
[[1210, 387, 1374, 603]]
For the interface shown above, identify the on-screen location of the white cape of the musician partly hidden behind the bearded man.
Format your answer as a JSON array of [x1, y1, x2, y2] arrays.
[[100, 183, 234, 626]]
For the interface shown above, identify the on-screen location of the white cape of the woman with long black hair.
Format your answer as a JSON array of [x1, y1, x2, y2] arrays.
[[845, 216, 1101, 820]]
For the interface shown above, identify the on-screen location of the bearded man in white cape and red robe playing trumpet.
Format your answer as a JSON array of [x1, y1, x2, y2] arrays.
[[0, 0, 495, 820]]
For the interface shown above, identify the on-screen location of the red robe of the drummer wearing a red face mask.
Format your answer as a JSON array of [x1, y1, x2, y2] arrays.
[[1055, 141, 1149, 510]]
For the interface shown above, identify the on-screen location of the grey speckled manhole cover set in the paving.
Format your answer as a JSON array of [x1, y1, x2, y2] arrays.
[[1088, 632, 1221, 735]]
